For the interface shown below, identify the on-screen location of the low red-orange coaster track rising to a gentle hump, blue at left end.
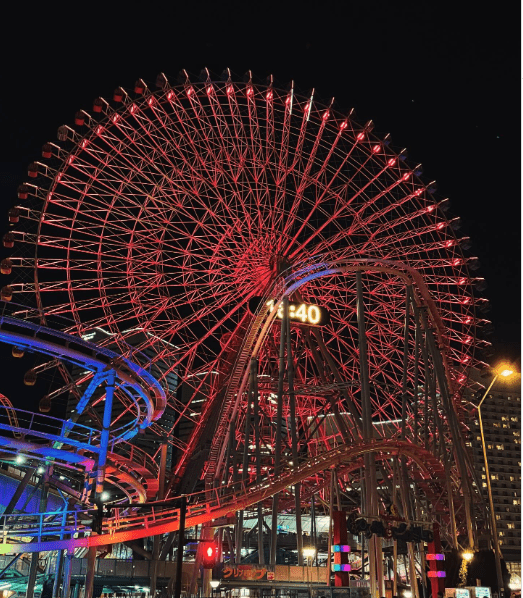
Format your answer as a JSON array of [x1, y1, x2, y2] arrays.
[[0, 440, 445, 554]]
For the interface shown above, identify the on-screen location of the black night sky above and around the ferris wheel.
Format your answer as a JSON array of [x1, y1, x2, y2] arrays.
[[0, 0, 521, 408]]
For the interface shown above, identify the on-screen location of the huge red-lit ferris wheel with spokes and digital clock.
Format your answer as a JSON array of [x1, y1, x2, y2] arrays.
[[4, 71, 486, 548]]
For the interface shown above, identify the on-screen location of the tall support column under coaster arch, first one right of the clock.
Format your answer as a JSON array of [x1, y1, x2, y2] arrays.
[[356, 271, 385, 598]]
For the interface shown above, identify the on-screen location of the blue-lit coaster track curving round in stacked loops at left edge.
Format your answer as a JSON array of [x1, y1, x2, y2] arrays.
[[0, 315, 166, 524]]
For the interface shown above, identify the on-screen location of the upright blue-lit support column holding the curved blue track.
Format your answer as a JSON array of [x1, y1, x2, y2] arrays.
[[84, 370, 115, 598]]
